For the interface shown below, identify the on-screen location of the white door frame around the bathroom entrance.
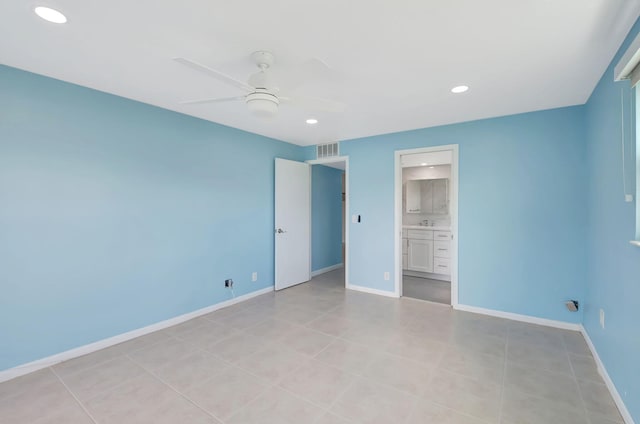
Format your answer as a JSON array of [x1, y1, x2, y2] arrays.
[[394, 144, 459, 308]]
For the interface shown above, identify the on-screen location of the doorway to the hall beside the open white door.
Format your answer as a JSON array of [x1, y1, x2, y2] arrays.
[[307, 156, 349, 287]]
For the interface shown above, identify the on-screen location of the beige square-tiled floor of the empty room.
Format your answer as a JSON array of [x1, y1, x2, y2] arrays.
[[0, 271, 622, 424]]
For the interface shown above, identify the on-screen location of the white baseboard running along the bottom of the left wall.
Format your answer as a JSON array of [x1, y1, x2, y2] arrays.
[[0, 287, 273, 383]]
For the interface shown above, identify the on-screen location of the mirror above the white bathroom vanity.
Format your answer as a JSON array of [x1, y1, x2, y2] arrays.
[[405, 178, 449, 215]]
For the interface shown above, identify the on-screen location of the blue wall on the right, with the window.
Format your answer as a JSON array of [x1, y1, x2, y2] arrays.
[[584, 16, 640, 422]]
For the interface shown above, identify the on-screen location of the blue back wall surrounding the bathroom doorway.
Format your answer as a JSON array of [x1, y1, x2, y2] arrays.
[[336, 107, 586, 323]]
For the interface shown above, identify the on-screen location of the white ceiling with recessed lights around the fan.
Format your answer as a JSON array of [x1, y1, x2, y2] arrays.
[[0, 0, 640, 145]]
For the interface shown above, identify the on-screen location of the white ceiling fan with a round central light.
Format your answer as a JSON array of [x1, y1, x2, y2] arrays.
[[173, 50, 345, 118]]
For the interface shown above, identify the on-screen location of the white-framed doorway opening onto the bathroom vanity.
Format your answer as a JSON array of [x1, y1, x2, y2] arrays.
[[395, 145, 458, 306]]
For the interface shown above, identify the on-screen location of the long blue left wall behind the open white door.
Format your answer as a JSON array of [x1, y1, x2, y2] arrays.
[[0, 66, 302, 370]]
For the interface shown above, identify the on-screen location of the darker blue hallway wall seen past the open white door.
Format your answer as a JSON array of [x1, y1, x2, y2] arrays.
[[311, 165, 344, 271]]
